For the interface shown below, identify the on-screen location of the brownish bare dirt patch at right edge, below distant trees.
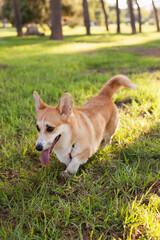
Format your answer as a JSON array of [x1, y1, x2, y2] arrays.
[[123, 47, 160, 58]]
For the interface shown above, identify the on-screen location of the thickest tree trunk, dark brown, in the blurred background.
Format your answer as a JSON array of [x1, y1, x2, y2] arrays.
[[50, 0, 63, 41]]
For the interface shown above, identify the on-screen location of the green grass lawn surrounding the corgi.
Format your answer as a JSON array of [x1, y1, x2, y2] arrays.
[[0, 25, 160, 240]]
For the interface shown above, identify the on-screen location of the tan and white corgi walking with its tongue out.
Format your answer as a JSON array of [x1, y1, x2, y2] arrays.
[[33, 75, 137, 176]]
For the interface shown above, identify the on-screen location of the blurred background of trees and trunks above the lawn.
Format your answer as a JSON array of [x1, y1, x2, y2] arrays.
[[0, 0, 160, 40]]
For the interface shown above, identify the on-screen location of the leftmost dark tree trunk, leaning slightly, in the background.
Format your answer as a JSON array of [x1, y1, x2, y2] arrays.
[[12, 0, 23, 37]]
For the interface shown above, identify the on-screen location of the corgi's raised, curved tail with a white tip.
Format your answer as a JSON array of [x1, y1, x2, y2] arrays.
[[99, 75, 137, 97]]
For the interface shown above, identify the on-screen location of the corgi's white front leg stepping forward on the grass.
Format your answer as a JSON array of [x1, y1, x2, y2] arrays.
[[62, 149, 90, 176]]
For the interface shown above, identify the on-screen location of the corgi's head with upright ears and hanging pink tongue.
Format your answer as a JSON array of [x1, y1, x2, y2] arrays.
[[33, 92, 74, 164]]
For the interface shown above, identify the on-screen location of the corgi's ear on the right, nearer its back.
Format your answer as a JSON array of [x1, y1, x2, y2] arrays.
[[57, 93, 73, 117]]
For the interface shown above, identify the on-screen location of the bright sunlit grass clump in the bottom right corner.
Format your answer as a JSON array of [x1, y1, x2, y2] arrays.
[[125, 191, 160, 240]]
